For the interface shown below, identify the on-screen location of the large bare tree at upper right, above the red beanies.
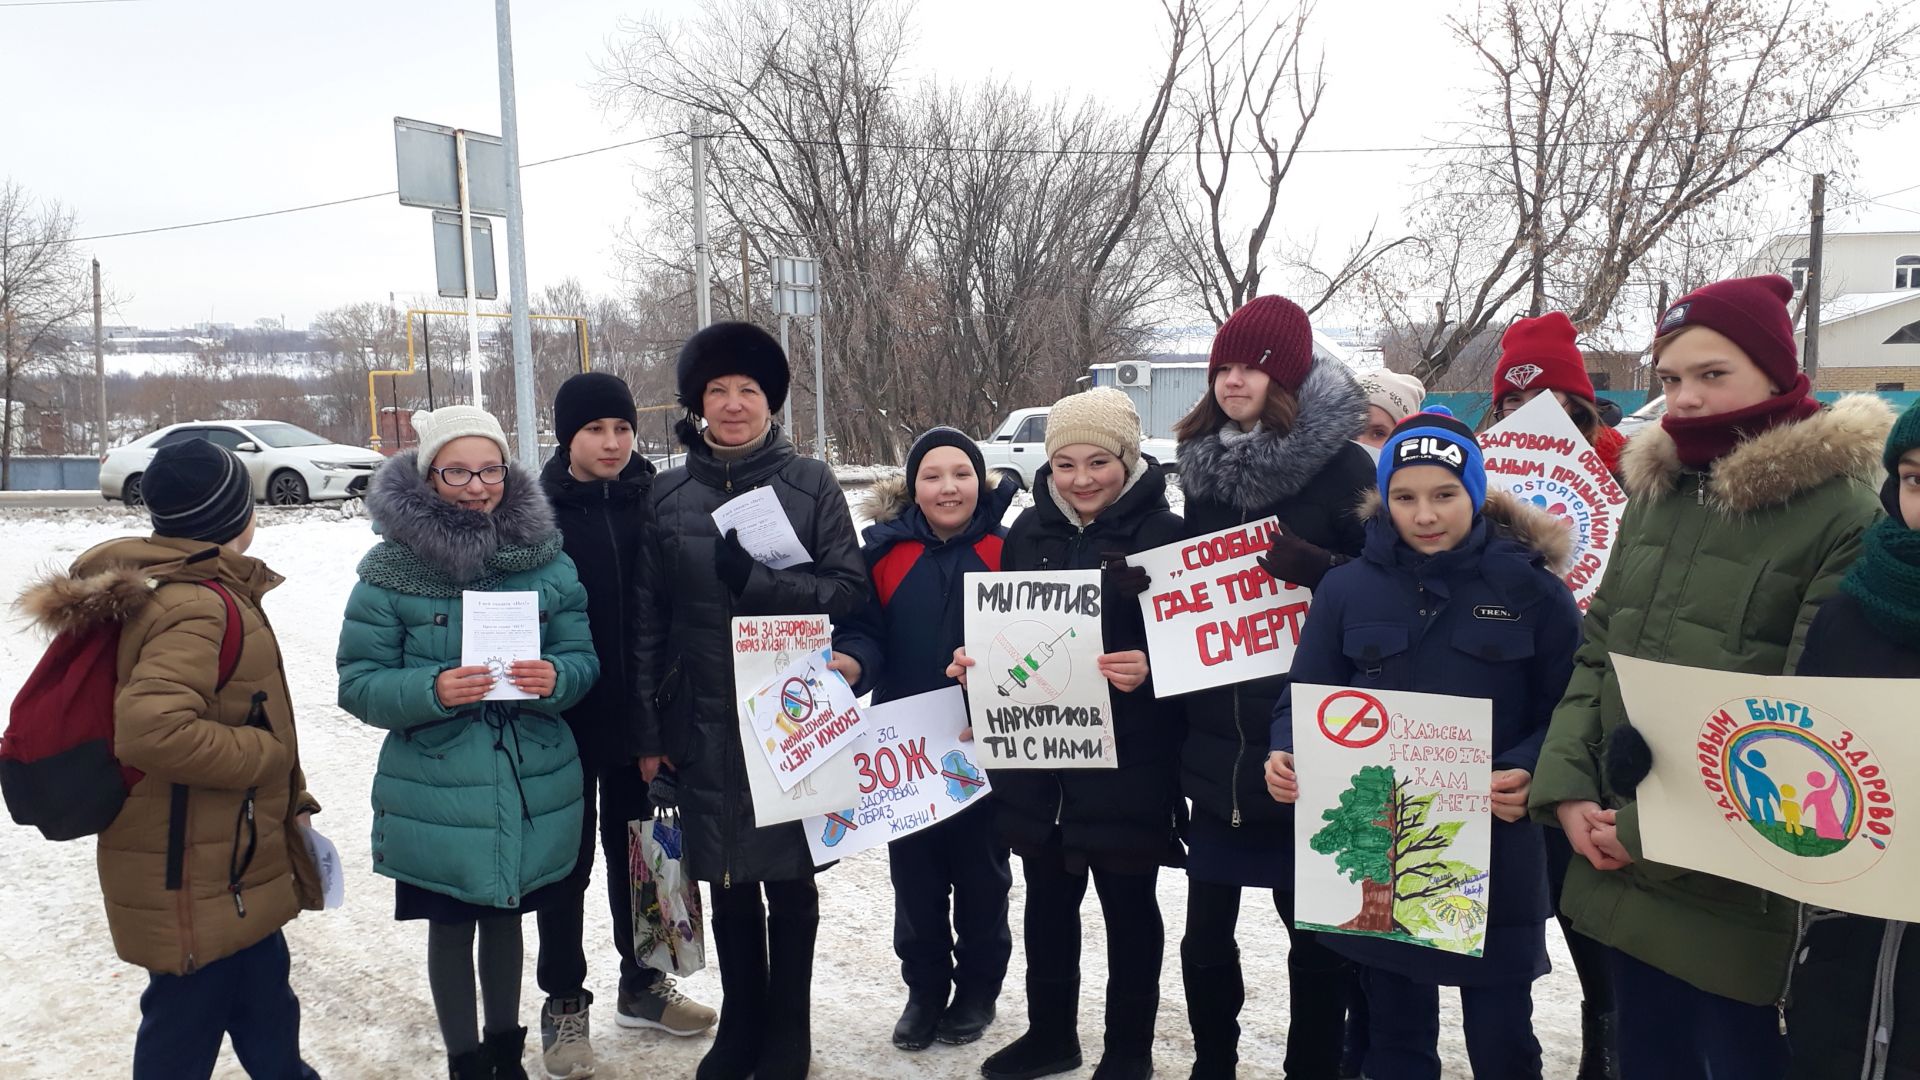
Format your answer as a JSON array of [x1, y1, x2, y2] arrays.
[[1369, 0, 1914, 379]]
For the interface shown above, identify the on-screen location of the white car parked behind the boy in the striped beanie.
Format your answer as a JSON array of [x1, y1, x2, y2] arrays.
[[100, 421, 386, 505]]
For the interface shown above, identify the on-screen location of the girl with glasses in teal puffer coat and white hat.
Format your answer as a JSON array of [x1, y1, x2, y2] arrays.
[[336, 405, 599, 1080]]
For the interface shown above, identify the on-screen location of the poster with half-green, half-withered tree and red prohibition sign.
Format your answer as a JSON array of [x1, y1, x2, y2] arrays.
[[1292, 682, 1494, 957]]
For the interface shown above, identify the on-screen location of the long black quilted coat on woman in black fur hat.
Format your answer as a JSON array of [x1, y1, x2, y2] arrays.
[[636, 425, 868, 884]]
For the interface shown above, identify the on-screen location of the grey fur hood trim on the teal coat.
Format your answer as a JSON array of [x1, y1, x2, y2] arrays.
[[367, 450, 559, 582]]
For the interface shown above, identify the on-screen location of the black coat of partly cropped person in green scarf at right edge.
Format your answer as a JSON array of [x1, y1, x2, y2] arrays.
[[1786, 592, 1920, 1080]]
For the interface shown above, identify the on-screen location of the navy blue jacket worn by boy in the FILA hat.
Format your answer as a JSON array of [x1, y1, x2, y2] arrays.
[[1273, 492, 1580, 986]]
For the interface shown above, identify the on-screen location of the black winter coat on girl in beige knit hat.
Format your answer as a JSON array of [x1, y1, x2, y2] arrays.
[[993, 461, 1187, 865]]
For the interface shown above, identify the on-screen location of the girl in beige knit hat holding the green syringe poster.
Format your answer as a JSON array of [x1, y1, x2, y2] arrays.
[[947, 388, 1187, 1080]]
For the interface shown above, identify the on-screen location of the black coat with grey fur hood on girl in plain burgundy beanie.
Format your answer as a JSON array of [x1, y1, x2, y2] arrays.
[[1181, 359, 1375, 841]]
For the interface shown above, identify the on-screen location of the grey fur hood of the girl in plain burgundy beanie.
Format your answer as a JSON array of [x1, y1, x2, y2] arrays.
[[1179, 349, 1367, 511]]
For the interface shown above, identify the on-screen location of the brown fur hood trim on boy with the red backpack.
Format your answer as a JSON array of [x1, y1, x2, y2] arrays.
[[13, 536, 280, 634]]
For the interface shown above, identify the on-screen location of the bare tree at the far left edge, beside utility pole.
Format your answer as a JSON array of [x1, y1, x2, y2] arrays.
[[0, 179, 92, 488]]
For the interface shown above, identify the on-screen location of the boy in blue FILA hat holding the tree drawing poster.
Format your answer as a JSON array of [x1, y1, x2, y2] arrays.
[[1267, 409, 1580, 1080]]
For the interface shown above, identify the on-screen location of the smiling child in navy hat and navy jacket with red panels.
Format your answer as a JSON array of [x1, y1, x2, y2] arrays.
[[833, 427, 1020, 1049]]
